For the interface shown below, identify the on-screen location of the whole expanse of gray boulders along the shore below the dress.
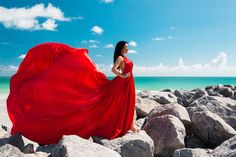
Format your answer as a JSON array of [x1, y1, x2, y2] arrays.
[[0, 85, 236, 157]]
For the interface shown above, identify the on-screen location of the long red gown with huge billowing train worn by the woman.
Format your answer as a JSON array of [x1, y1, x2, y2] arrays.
[[7, 43, 135, 144]]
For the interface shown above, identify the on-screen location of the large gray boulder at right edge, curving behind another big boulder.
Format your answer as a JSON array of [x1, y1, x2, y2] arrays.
[[187, 96, 236, 129]]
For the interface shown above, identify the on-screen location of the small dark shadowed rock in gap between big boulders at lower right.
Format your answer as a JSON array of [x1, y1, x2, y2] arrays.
[[185, 134, 206, 148]]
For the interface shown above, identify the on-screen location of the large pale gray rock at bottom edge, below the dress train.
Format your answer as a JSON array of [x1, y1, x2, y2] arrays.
[[52, 135, 120, 157]]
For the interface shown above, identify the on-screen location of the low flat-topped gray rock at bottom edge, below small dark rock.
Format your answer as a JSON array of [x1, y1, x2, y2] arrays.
[[174, 148, 213, 157]]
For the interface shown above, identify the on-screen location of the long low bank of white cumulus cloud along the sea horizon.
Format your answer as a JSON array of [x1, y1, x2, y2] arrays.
[[92, 52, 236, 76]]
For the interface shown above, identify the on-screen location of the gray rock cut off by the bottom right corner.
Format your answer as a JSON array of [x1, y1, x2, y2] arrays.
[[212, 136, 236, 157]]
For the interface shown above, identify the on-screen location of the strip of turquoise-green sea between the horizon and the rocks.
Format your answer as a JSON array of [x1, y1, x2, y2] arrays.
[[0, 76, 236, 94]]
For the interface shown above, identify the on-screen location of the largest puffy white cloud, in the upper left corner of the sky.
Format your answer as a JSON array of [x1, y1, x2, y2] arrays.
[[0, 3, 82, 31]]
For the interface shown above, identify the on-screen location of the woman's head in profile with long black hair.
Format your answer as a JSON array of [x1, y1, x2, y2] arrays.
[[114, 41, 128, 63]]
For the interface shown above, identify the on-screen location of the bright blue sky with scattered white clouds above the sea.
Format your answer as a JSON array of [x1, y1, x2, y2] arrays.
[[0, 0, 236, 76]]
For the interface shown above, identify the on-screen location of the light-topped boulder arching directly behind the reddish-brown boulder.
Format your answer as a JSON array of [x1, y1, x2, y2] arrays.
[[148, 103, 191, 131]]
